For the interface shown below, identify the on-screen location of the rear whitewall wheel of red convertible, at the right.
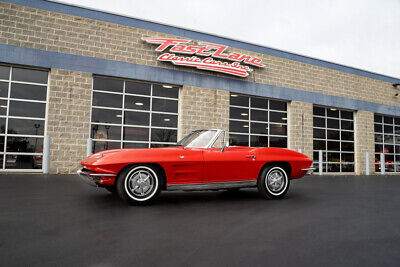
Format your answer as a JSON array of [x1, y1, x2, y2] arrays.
[[257, 166, 290, 199]]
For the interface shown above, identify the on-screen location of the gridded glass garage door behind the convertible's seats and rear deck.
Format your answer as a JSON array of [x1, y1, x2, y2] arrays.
[[229, 93, 287, 147]]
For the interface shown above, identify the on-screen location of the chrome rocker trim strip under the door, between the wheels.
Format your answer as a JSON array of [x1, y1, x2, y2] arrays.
[[167, 180, 257, 191]]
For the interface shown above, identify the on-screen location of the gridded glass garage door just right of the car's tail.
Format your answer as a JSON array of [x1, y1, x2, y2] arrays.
[[313, 106, 354, 173]]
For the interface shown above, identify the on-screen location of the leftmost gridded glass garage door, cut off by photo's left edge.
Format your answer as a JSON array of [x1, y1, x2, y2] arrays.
[[0, 65, 48, 171]]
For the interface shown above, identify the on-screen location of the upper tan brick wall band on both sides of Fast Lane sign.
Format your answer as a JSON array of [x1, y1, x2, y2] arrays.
[[0, 3, 400, 109]]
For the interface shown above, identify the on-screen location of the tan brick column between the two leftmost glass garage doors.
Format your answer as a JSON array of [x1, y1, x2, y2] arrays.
[[47, 69, 92, 174]]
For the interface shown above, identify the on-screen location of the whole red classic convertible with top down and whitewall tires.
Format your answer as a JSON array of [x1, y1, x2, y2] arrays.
[[78, 129, 313, 203]]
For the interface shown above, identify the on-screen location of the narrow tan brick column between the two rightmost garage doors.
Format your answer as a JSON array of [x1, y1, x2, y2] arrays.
[[354, 110, 375, 175]]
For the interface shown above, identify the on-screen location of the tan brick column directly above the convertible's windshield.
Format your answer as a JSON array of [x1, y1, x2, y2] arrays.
[[178, 86, 229, 139]]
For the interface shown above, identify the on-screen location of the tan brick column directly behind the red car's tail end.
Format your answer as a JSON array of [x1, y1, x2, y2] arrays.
[[288, 101, 313, 159]]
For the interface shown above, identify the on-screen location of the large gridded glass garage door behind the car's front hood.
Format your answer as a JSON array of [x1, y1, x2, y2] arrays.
[[91, 77, 179, 152]]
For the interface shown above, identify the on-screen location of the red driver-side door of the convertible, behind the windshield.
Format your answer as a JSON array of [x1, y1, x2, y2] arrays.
[[203, 147, 258, 183]]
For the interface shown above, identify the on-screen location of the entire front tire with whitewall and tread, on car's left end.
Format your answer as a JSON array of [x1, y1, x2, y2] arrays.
[[117, 165, 161, 204]]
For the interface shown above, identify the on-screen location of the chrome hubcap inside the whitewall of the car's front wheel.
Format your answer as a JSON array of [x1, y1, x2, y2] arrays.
[[127, 170, 154, 197]]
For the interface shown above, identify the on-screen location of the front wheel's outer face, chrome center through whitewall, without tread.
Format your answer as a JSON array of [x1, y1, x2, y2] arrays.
[[125, 166, 158, 201]]
